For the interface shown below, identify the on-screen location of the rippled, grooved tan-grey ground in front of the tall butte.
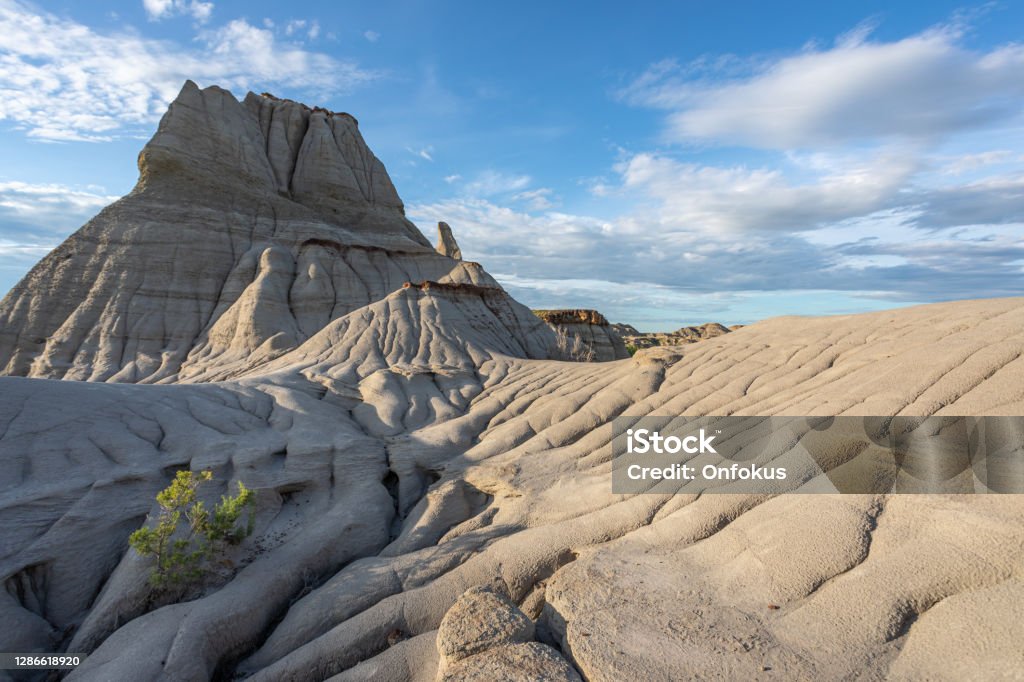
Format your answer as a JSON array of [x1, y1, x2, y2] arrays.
[[0, 290, 1024, 680]]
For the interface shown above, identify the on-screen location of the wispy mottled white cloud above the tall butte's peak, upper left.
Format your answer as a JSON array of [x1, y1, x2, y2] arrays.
[[0, 0, 377, 140]]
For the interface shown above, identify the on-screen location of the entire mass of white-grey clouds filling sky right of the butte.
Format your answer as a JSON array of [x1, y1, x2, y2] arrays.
[[481, 15, 1024, 326]]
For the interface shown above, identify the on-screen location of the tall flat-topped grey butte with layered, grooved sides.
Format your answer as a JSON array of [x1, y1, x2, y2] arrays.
[[0, 82, 561, 383]]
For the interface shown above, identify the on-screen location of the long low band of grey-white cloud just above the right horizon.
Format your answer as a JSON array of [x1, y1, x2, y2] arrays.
[[408, 180, 1024, 322]]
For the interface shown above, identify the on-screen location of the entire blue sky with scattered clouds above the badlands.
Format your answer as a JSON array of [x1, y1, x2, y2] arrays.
[[0, 0, 1024, 331]]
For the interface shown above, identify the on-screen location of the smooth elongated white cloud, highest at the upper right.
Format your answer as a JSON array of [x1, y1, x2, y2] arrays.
[[620, 27, 1024, 148]]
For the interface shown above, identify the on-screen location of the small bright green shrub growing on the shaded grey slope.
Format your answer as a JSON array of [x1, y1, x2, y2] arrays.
[[128, 471, 256, 589]]
